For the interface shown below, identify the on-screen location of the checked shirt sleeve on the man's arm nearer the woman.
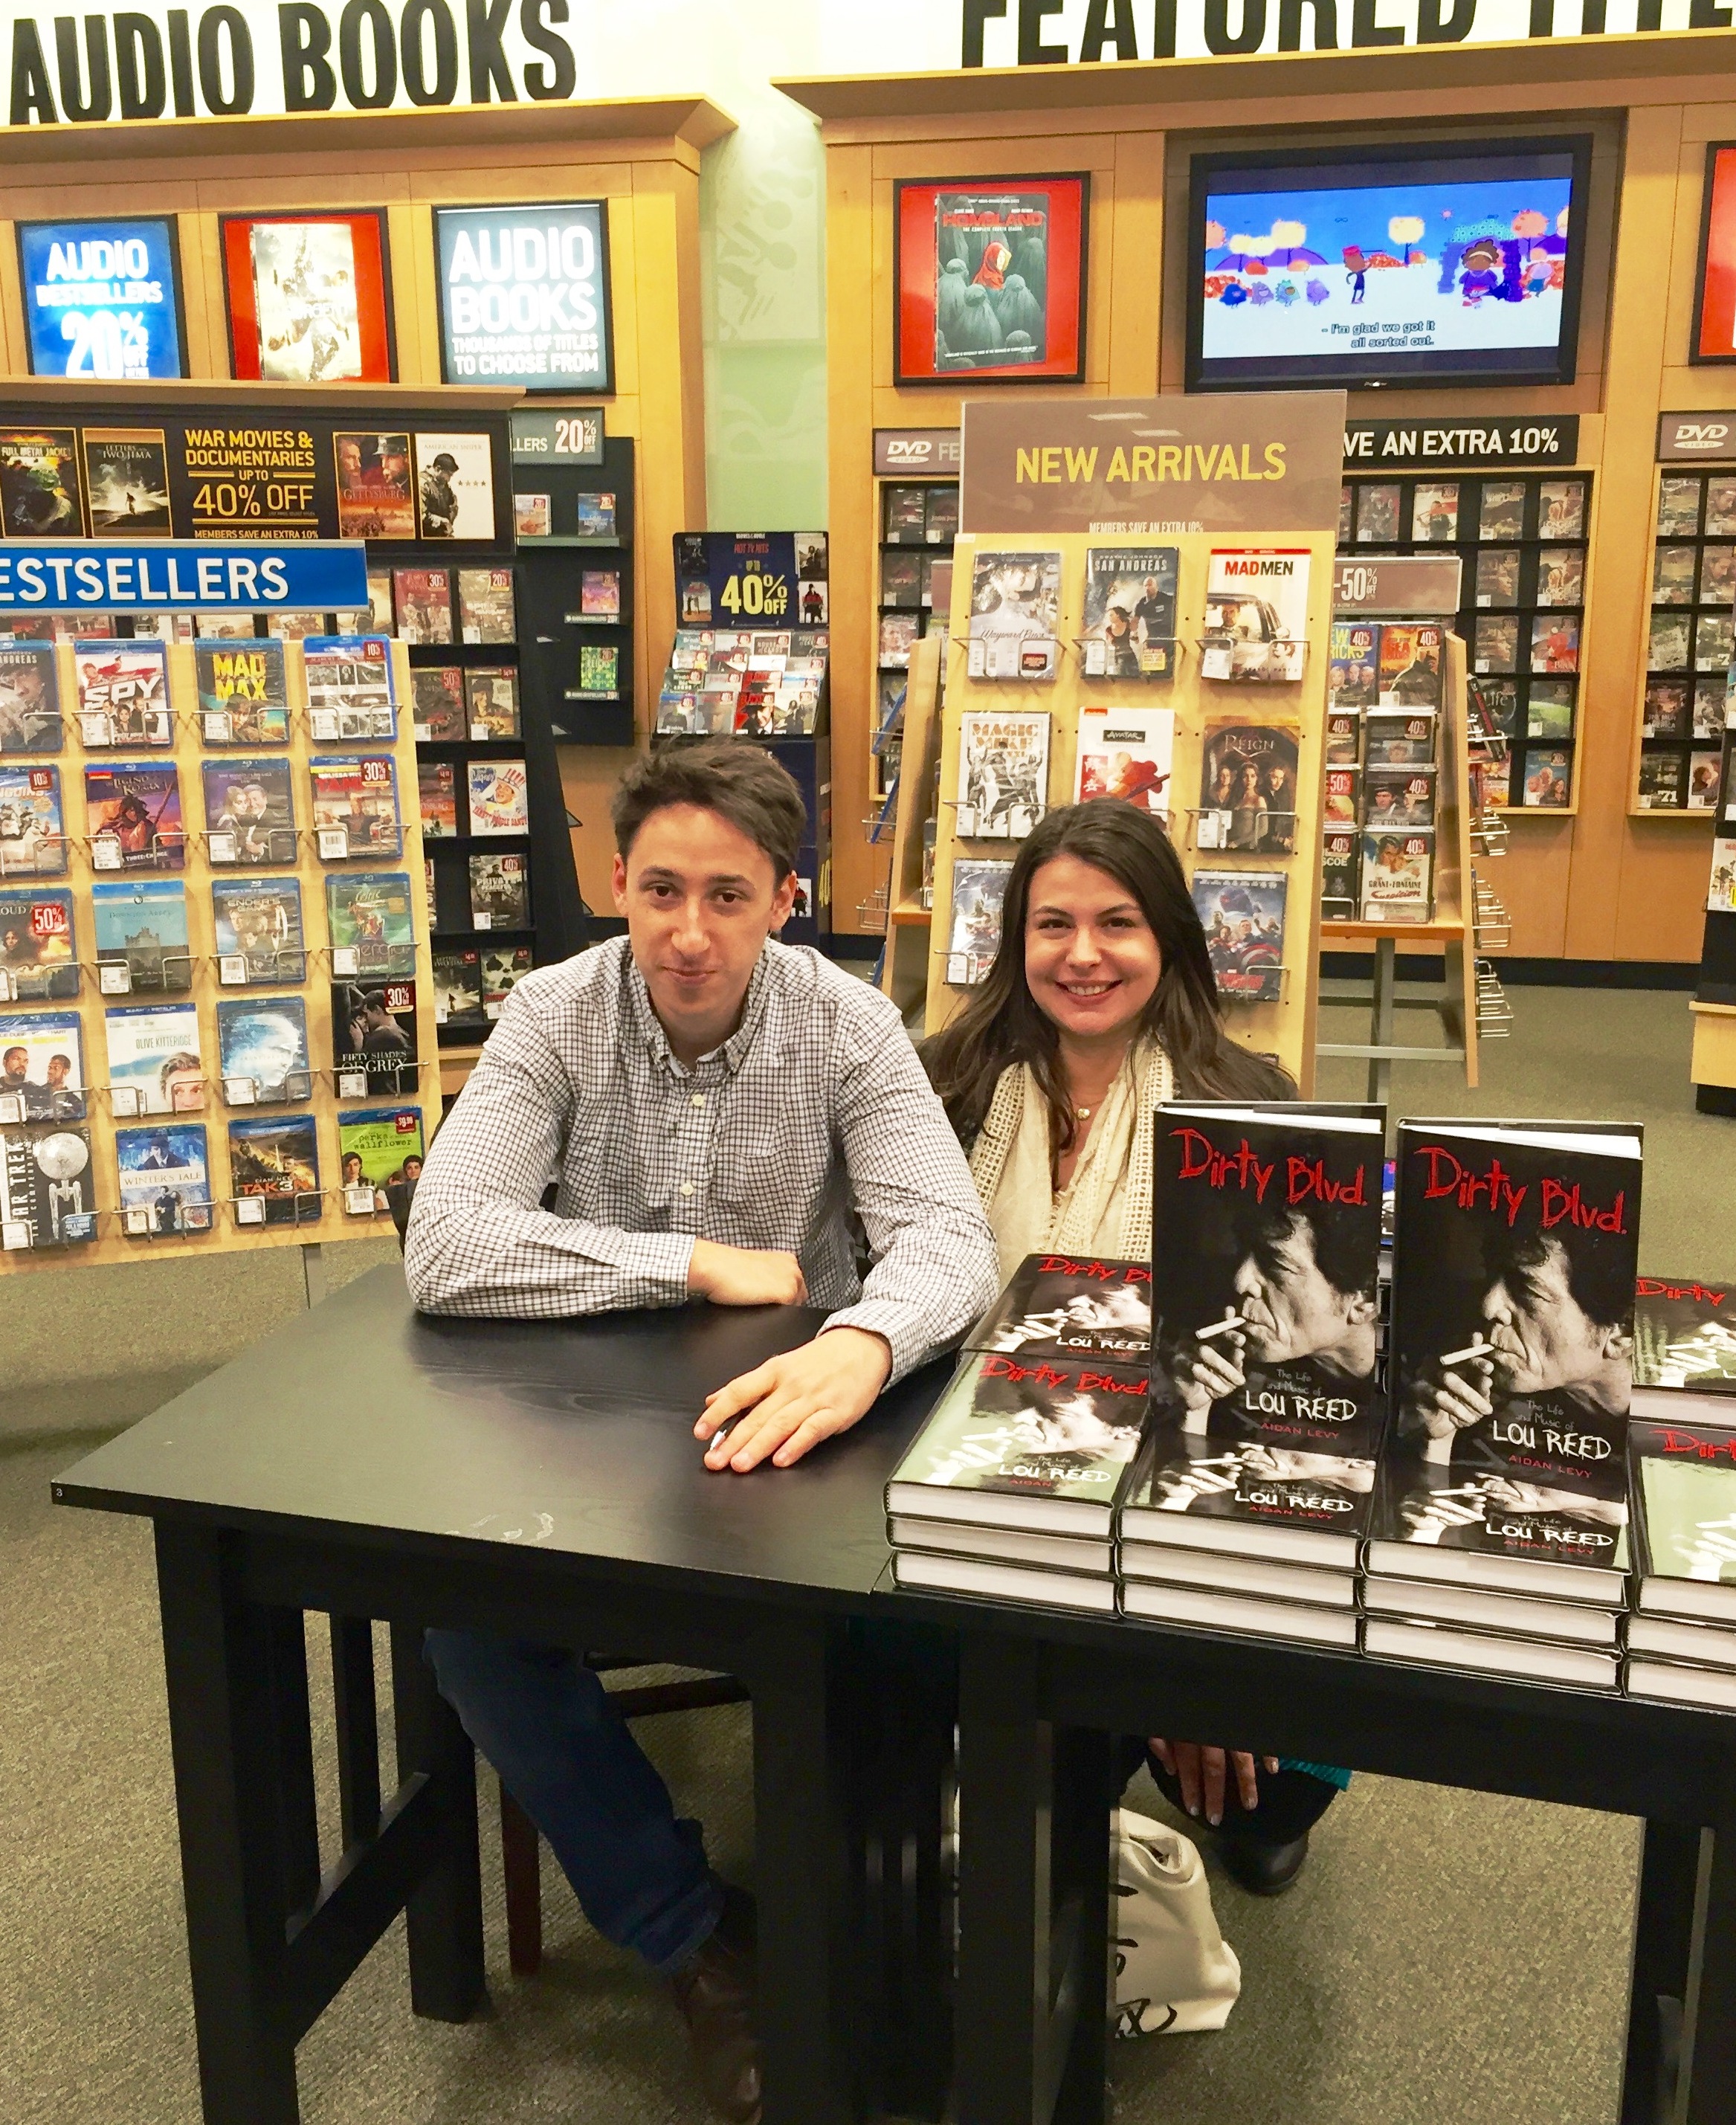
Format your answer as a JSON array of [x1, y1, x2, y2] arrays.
[[827, 1022, 1001, 1384]]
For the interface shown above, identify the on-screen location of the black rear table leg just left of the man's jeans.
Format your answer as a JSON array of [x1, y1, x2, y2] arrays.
[[391, 1624, 486, 2021]]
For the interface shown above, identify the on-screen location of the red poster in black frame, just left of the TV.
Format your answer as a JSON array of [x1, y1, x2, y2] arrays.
[[892, 174, 1090, 389]]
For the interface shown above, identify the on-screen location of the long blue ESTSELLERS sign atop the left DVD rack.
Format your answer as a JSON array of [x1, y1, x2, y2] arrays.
[[0, 540, 367, 616]]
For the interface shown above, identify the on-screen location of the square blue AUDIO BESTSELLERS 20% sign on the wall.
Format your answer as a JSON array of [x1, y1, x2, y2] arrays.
[[19, 217, 187, 381]]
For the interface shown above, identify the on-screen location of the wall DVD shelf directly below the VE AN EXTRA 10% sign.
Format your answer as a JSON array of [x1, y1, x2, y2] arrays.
[[1339, 471, 1594, 814]]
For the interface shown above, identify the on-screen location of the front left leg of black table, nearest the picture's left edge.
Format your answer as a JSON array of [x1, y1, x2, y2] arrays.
[[157, 1521, 300, 2125]]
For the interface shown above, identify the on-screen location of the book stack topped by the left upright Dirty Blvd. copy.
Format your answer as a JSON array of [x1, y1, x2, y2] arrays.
[[1117, 1103, 1385, 1647]]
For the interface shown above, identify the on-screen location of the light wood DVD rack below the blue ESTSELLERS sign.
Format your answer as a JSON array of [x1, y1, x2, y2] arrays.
[[0, 616, 440, 1273]]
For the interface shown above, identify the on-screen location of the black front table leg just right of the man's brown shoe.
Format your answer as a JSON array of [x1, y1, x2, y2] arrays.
[[743, 1624, 860, 2125]]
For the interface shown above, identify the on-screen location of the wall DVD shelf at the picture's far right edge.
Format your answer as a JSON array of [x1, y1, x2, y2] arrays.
[[1630, 465, 1736, 818]]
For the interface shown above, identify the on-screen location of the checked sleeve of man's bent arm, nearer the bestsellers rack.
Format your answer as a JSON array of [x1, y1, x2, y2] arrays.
[[404, 990, 693, 1320]]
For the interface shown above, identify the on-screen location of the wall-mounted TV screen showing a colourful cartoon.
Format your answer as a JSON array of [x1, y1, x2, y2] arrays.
[[1188, 136, 1592, 391]]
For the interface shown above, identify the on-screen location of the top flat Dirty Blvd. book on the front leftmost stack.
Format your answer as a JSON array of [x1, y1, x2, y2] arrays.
[[886, 1352, 1145, 1534]]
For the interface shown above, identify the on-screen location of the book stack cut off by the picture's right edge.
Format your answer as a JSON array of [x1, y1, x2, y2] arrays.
[[1624, 1396, 1736, 1711]]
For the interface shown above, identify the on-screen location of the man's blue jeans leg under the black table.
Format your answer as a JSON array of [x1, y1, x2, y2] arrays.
[[427, 1630, 723, 1970]]
